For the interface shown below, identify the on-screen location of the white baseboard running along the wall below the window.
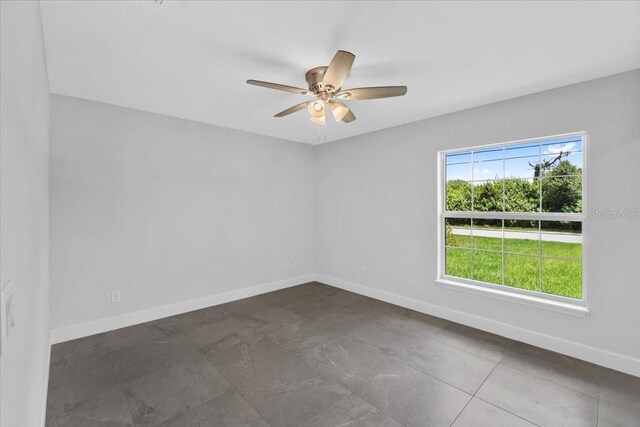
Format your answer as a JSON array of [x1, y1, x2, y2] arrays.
[[315, 274, 640, 377]]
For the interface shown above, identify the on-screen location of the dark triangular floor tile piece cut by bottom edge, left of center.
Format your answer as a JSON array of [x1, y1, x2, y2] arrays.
[[158, 390, 269, 427]]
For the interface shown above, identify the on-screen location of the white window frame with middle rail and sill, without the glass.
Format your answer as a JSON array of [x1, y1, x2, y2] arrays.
[[436, 131, 589, 316]]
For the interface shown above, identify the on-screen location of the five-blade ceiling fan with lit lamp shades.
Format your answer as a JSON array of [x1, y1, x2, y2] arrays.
[[247, 50, 407, 125]]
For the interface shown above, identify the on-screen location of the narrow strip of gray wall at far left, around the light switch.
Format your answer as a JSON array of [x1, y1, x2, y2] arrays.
[[0, 1, 49, 427]]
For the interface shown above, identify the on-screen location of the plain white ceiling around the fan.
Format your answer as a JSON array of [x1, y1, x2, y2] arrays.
[[41, 0, 640, 143]]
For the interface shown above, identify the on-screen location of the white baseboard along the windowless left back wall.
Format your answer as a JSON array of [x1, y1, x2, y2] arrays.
[[51, 274, 315, 344]]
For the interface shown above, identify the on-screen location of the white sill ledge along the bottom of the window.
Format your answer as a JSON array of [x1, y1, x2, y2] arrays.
[[436, 278, 589, 317]]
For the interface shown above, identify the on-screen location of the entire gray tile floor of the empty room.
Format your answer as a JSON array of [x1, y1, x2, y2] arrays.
[[47, 283, 640, 427]]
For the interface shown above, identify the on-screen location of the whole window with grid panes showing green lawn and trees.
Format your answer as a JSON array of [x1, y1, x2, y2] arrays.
[[438, 133, 586, 312]]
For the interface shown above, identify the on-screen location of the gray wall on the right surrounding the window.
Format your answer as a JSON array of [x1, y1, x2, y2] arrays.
[[316, 71, 640, 374]]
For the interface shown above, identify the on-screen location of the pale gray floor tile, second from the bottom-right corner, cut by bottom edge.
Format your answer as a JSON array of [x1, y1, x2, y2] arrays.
[[476, 365, 598, 426]]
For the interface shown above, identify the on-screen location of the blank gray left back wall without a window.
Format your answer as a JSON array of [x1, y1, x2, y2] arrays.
[[51, 95, 315, 332]]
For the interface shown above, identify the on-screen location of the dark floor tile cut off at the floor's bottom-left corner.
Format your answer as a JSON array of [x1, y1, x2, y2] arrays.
[[47, 387, 133, 427]]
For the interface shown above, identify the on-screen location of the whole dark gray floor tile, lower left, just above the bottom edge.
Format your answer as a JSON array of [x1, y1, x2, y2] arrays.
[[123, 357, 231, 425]]
